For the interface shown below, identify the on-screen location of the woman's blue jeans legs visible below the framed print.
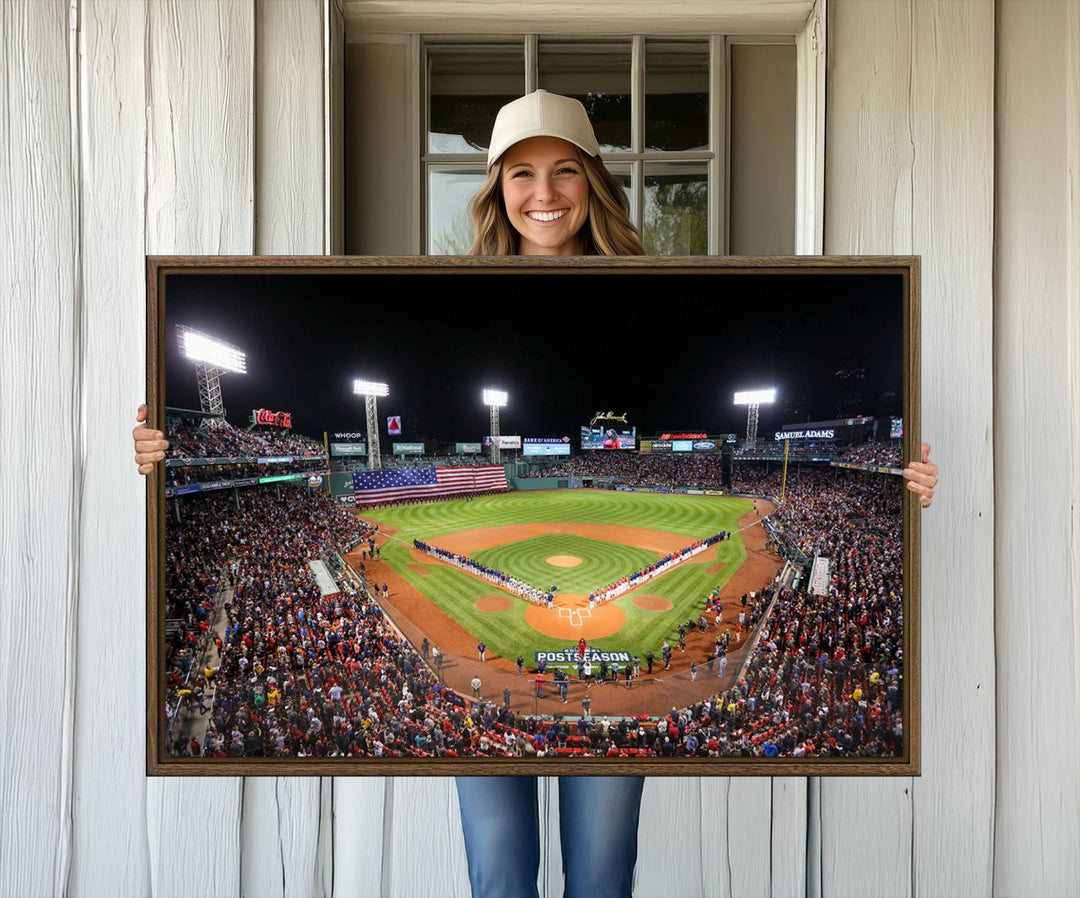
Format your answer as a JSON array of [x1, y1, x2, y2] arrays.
[[457, 776, 645, 898]]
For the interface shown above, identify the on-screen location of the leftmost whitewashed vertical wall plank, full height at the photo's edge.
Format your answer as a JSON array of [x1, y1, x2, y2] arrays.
[[0, 0, 83, 896]]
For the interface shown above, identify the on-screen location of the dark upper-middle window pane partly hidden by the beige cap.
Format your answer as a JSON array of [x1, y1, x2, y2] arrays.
[[538, 40, 631, 152]]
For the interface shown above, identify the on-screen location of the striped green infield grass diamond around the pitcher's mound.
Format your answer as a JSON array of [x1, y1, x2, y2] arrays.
[[472, 533, 660, 595]]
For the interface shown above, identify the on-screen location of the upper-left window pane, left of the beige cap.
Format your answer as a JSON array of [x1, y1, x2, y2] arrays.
[[428, 43, 525, 152]]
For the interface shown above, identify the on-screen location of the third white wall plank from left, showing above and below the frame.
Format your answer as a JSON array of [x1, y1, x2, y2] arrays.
[[146, 0, 255, 896]]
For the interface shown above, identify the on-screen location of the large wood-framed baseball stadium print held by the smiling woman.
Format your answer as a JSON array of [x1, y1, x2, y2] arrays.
[[147, 257, 919, 776]]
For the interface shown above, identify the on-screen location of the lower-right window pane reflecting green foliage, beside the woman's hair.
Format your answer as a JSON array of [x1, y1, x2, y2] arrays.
[[644, 162, 708, 256]]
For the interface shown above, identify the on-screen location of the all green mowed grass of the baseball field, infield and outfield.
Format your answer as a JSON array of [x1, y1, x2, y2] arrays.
[[363, 490, 753, 664]]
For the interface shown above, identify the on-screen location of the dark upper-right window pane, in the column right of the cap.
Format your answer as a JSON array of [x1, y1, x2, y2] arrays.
[[645, 41, 708, 151]]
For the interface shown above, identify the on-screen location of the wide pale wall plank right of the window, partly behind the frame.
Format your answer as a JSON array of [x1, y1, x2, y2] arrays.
[[821, 0, 995, 896]]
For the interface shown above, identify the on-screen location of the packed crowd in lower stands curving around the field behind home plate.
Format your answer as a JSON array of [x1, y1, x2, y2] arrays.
[[166, 453, 904, 758]]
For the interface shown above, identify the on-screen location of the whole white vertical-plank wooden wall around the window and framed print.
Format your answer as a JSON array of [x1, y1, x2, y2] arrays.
[[0, 0, 1080, 898]]
